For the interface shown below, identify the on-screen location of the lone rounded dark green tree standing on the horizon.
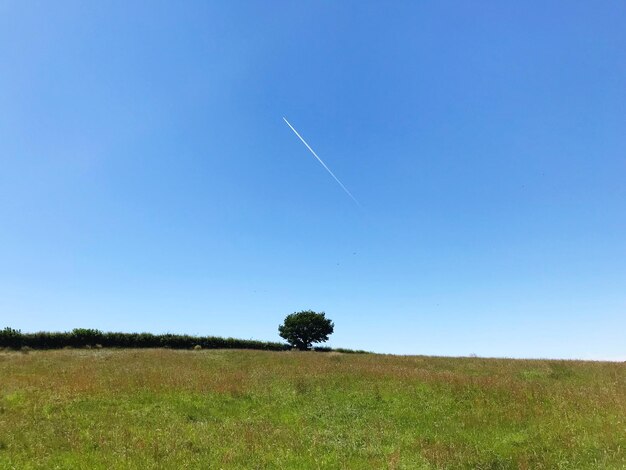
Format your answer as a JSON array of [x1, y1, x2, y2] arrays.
[[278, 310, 335, 351]]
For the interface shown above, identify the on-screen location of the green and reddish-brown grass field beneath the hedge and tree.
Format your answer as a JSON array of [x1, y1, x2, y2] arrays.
[[0, 349, 626, 470]]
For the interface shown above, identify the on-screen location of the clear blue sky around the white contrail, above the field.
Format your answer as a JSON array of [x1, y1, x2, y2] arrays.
[[0, 0, 626, 359]]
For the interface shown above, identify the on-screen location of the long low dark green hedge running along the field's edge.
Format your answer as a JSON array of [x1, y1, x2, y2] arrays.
[[0, 327, 365, 353]]
